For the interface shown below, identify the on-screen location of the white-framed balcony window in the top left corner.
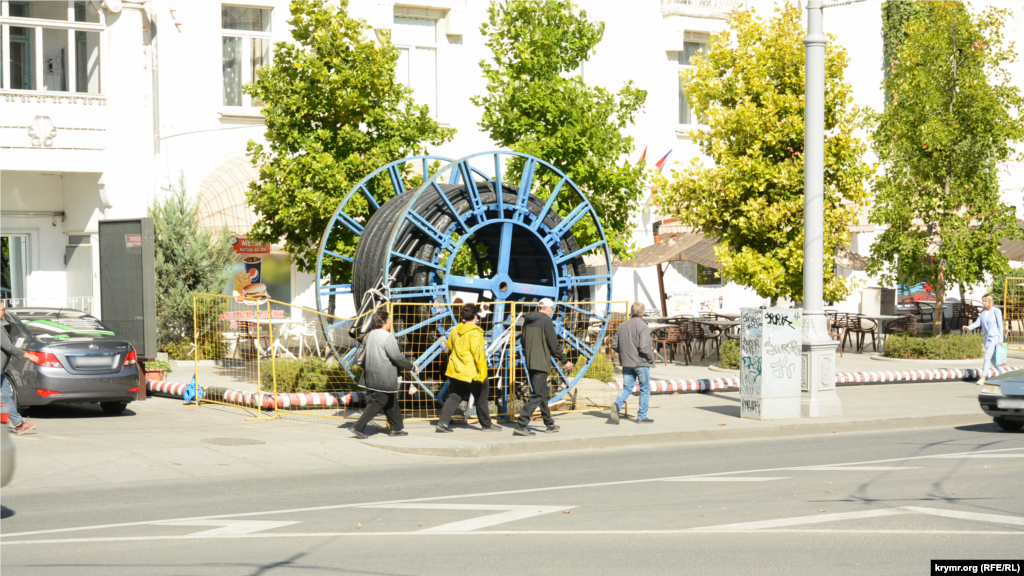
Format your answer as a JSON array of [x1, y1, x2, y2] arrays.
[[0, 0, 104, 94]]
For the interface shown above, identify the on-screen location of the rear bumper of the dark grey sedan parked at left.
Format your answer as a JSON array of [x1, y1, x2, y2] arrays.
[[17, 366, 139, 406]]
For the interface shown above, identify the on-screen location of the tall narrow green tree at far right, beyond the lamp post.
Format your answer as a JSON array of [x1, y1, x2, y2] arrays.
[[868, 0, 1024, 334]]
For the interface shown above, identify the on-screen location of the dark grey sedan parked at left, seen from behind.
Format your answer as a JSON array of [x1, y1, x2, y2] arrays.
[[4, 307, 139, 414]]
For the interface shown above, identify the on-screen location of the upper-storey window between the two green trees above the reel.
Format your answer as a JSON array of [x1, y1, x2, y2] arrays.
[[391, 15, 437, 118]]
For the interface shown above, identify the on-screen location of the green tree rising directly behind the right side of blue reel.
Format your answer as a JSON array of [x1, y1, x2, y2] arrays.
[[472, 0, 647, 257]]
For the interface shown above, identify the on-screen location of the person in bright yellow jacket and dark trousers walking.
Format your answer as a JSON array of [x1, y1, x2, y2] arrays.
[[436, 303, 501, 433]]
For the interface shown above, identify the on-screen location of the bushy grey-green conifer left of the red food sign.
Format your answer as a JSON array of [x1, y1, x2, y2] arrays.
[[150, 176, 234, 344]]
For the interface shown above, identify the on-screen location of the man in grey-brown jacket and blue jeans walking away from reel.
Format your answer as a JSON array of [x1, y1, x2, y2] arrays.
[[608, 302, 654, 424]]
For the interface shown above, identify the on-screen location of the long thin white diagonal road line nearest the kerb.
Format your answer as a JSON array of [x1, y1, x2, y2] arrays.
[[0, 440, 1020, 543]]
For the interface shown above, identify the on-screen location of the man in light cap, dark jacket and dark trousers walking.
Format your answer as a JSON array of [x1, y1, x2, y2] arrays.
[[512, 298, 572, 436]]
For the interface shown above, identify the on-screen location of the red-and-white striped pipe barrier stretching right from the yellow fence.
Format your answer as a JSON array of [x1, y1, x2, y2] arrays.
[[608, 366, 1021, 394]]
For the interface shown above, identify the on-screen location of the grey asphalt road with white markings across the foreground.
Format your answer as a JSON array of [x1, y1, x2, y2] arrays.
[[0, 424, 1024, 576]]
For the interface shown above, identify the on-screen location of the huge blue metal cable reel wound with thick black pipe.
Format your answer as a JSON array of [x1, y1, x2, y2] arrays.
[[317, 152, 611, 404]]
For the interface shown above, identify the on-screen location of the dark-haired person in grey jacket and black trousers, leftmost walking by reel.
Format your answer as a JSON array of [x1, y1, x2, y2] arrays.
[[352, 310, 420, 440]]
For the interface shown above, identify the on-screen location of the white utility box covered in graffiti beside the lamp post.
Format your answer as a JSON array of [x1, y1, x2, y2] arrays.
[[739, 308, 803, 420]]
